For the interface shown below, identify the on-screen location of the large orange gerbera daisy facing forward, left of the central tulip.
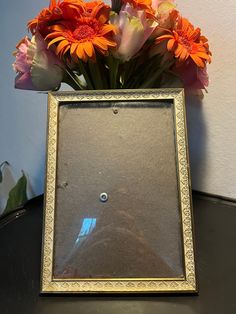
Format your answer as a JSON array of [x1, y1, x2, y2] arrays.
[[46, 17, 116, 62]]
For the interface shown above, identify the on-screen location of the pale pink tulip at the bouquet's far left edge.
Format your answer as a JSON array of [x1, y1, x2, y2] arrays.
[[13, 34, 63, 91]]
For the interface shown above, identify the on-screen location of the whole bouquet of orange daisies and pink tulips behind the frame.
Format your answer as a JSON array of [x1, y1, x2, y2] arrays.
[[13, 0, 211, 91]]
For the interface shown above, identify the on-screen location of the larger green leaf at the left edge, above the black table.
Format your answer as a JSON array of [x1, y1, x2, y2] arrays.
[[3, 171, 28, 214]]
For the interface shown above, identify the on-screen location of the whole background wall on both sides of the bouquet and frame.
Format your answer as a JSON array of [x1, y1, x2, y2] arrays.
[[0, 0, 236, 198]]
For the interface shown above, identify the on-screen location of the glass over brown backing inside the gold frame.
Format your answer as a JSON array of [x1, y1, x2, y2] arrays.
[[53, 101, 184, 278]]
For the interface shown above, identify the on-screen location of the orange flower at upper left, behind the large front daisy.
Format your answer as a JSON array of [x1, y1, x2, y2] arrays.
[[27, 0, 84, 37]]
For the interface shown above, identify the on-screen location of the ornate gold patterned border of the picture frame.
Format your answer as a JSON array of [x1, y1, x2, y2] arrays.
[[41, 89, 197, 293]]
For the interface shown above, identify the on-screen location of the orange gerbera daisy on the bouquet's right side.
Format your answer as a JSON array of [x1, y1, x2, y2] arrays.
[[156, 16, 211, 68]]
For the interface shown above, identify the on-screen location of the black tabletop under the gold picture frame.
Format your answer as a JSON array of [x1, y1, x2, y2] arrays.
[[0, 194, 236, 314]]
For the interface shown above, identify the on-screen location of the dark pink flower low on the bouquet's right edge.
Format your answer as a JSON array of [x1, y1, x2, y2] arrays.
[[175, 60, 209, 90]]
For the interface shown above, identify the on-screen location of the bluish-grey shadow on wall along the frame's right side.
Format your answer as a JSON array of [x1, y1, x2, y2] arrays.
[[186, 93, 207, 191]]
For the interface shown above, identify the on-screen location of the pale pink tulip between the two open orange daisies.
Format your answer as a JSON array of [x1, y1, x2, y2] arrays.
[[111, 3, 157, 62]]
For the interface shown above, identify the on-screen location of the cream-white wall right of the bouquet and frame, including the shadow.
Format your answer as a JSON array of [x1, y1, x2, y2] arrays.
[[178, 0, 236, 199]]
